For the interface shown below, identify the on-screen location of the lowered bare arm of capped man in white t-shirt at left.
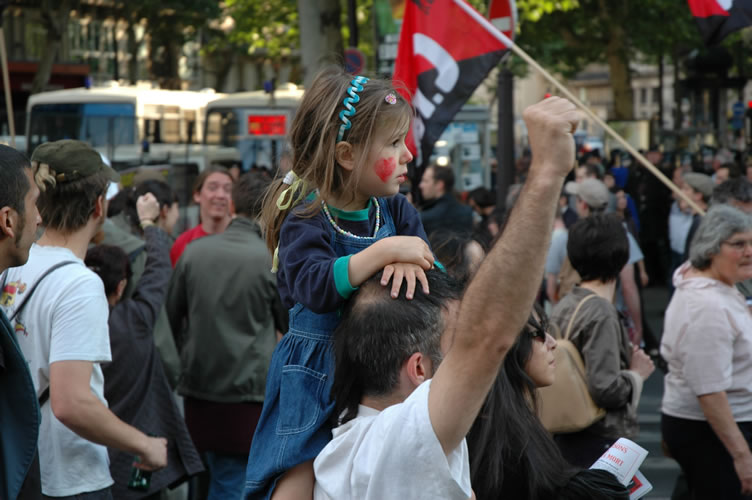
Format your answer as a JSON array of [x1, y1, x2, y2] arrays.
[[50, 361, 167, 470]]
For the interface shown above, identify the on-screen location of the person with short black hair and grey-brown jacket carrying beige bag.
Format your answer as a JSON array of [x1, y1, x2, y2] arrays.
[[551, 214, 653, 467]]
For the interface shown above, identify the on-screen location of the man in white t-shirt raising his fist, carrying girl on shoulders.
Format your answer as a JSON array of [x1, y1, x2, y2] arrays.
[[314, 97, 580, 500]]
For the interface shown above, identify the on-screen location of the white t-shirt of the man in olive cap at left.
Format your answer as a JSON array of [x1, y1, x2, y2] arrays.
[[0, 244, 113, 496]]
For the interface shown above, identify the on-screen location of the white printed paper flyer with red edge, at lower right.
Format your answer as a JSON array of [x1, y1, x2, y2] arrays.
[[590, 438, 653, 500]]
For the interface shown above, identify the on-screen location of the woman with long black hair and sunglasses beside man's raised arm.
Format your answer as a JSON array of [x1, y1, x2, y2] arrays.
[[467, 304, 629, 500]]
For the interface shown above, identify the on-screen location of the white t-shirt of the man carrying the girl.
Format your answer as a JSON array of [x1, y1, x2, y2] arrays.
[[313, 380, 472, 500]]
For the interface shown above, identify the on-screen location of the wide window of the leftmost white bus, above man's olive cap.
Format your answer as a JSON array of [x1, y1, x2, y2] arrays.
[[27, 102, 136, 152]]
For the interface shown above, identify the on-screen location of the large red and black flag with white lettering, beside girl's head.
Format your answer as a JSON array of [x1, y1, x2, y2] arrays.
[[394, 0, 507, 166]]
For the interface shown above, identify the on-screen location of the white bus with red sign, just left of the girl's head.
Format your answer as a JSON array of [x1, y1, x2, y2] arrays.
[[204, 84, 303, 171]]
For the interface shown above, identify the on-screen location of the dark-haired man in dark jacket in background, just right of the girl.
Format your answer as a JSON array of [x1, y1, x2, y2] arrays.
[[418, 165, 473, 236]]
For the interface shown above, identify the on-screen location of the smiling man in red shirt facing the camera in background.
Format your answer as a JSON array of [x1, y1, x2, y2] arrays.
[[170, 166, 233, 267]]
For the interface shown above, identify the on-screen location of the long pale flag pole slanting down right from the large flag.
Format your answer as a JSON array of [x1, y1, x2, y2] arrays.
[[454, 0, 705, 215]]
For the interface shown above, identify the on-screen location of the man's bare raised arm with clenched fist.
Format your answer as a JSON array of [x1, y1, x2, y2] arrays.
[[428, 97, 580, 453]]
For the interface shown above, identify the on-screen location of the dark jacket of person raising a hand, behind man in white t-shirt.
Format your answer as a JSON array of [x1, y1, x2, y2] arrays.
[[102, 227, 203, 498]]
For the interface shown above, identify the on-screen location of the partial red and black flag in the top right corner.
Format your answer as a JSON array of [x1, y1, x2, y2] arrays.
[[688, 0, 752, 45]]
